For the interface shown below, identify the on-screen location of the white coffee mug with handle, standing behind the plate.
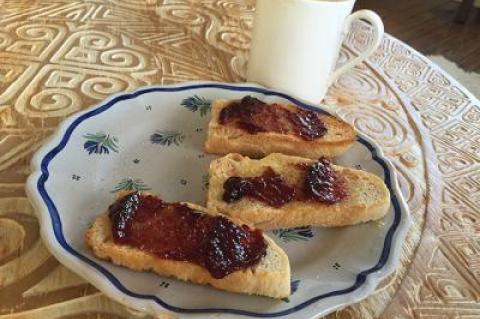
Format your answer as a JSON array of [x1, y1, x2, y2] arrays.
[[247, 0, 383, 104]]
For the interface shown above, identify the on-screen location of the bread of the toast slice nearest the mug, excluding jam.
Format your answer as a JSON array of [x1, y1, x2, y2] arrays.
[[205, 100, 356, 159]]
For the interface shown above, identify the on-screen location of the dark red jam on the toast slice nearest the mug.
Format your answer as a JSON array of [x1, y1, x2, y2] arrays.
[[219, 96, 327, 141]]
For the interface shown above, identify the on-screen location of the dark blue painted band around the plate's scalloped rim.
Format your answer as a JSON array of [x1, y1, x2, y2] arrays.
[[32, 83, 402, 317]]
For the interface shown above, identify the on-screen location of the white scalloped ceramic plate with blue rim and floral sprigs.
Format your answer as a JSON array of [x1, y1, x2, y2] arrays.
[[27, 82, 410, 318]]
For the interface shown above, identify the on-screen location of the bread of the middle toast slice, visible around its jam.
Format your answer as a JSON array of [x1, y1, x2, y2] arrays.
[[207, 154, 390, 230]]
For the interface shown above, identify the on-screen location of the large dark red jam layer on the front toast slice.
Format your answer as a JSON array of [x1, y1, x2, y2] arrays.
[[109, 193, 267, 278]]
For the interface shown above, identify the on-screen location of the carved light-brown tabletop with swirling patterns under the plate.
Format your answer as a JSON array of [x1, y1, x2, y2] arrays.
[[0, 0, 480, 319]]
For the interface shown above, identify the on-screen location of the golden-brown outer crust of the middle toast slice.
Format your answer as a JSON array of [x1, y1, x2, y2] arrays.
[[207, 153, 390, 230]]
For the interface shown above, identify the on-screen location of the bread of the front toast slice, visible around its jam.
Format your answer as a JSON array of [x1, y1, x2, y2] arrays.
[[85, 195, 290, 298]]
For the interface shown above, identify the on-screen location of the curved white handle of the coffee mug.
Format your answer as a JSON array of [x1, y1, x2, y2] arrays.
[[329, 10, 384, 84]]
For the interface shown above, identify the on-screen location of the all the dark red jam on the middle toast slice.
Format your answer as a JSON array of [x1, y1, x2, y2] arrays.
[[223, 158, 347, 208]]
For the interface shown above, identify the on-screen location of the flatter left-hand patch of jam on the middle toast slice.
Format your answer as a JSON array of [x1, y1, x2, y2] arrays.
[[223, 167, 295, 207]]
